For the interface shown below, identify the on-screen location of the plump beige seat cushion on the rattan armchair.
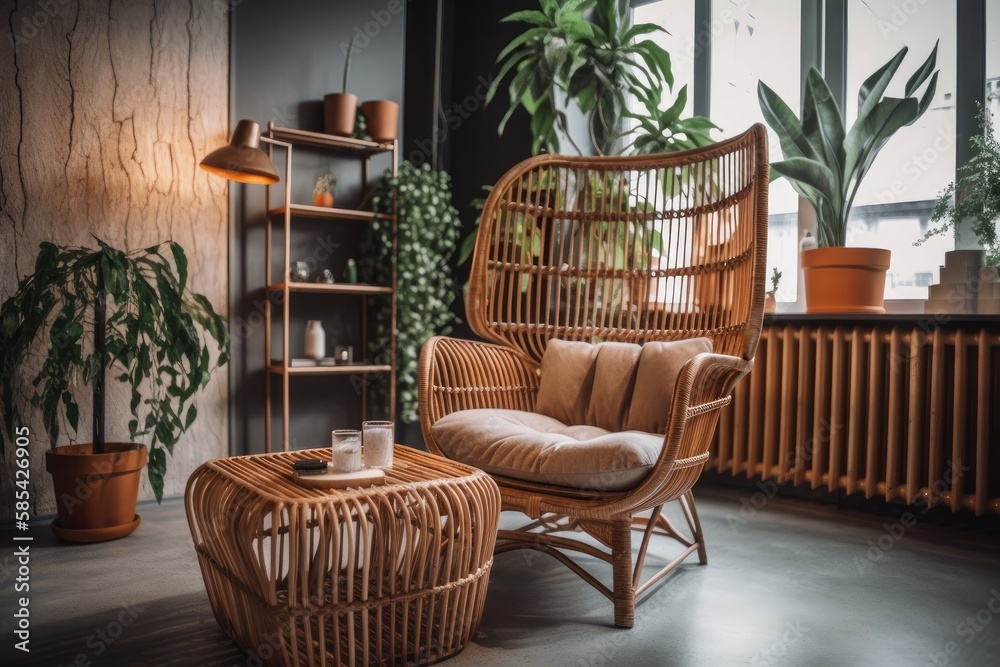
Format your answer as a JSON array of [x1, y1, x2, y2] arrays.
[[431, 409, 663, 491]]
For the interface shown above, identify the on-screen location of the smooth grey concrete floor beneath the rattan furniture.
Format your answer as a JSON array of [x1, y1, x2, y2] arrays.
[[0, 487, 1000, 667]]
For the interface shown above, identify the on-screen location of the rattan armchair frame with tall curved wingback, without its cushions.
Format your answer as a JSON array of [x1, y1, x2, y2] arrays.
[[419, 124, 768, 627]]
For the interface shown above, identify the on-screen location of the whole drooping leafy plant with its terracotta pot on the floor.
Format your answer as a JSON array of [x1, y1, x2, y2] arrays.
[[0, 239, 229, 542]]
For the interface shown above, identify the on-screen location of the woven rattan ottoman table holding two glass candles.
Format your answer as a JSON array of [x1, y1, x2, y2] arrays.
[[185, 445, 500, 667]]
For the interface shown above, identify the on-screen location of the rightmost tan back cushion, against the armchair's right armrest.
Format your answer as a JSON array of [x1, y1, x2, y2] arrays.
[[625, 338, 712, 434]]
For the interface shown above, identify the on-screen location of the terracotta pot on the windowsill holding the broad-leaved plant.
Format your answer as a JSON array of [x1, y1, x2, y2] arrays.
[[801, 248, 889, 313]]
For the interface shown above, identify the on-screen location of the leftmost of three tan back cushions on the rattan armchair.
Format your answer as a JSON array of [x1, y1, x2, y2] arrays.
[[535, 338, 597, 424]]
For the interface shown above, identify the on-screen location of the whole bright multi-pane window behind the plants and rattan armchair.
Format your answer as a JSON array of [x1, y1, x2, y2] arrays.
[[635, 0, 988, 302]]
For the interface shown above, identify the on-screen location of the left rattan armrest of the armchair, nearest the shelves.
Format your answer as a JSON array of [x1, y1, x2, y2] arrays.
[[417, 336, 539, 454]]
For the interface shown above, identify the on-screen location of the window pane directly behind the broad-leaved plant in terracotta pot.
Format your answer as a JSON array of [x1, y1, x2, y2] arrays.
[[845, 0, 956, 299]]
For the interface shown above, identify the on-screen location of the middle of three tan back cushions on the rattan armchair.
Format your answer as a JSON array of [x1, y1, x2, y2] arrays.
[[583, 343, 642, 431]]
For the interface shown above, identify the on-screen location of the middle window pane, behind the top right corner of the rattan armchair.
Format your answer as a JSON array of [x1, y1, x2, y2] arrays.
[[709, 0, 802, 301]]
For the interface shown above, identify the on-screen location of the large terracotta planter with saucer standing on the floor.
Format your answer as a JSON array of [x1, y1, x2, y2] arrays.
[[45, 443, 148, 542]]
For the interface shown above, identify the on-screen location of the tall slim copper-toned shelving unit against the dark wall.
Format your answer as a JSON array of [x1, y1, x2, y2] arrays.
[[264, 122, 399, 452]]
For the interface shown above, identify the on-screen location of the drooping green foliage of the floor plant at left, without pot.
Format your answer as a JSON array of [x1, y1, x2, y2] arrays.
[[0, 239, 229, 501]]
